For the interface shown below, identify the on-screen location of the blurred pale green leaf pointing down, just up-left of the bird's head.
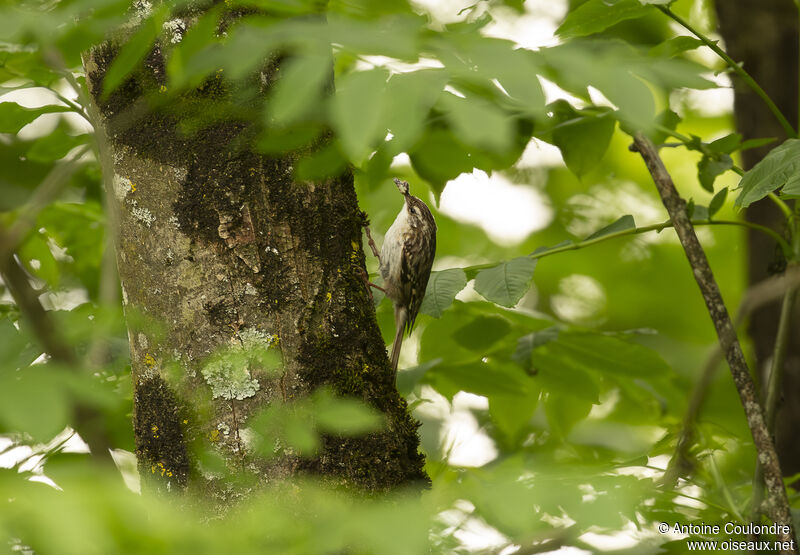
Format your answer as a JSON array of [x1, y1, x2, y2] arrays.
[[331, 68, 389, 165]]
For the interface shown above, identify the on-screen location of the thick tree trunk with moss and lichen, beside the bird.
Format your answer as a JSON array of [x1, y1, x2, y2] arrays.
[[85, 19, 427, 503]]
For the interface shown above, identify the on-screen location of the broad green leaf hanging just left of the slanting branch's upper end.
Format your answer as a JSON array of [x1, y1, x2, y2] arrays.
[[552, 112, 616, 178]]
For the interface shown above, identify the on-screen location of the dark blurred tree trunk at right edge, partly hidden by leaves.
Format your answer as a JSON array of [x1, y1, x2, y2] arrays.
[[716, 0, 800, 476]]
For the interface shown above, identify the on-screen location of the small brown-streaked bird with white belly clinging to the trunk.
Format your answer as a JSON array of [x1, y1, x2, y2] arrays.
[[379, 178, 436, 373]]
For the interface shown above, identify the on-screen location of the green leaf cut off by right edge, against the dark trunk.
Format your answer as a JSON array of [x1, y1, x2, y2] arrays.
[[736, 139, 800, 208]]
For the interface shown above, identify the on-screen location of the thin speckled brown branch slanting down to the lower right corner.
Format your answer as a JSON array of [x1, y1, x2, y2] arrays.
[[632, 133, 797, 553]]
